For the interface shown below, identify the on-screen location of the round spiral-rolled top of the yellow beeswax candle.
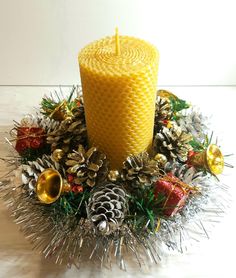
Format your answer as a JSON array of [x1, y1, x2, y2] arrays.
[[78, 36, 159, 76]]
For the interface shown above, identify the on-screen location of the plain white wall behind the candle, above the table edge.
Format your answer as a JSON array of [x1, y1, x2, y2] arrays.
[[0, 0, 236, 85]]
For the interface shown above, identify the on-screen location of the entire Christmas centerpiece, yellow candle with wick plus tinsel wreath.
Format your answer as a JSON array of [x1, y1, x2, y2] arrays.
[[1, 33, 230, 269]]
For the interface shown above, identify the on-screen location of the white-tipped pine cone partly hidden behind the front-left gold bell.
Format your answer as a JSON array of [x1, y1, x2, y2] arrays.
[[22, 155, 65, 195]]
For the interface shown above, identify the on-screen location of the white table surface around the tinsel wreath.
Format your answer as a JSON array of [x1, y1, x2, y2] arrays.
[[0, 87, 236, 278]]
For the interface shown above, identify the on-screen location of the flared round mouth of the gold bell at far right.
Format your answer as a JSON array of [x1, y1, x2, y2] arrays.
[[206, 144, 224, 175]]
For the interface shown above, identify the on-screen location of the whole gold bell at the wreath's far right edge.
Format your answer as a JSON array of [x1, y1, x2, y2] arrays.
[[189, 144, 224, 175]]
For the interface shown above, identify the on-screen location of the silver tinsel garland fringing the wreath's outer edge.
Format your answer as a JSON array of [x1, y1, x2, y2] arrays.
[[0, 92, 231, 270]]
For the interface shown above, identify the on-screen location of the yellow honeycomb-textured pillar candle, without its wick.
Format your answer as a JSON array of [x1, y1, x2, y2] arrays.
[[79, 36, 159, 169]]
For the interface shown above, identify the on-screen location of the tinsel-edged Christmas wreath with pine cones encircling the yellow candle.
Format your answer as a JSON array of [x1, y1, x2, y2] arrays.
[[0, 87, 231, 269]]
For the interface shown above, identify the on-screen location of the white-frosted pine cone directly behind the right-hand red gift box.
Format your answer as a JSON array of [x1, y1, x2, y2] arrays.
[[164, 162, 204, 185]]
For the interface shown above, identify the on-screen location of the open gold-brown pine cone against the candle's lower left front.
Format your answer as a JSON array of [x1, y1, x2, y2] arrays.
[[66, 145, 108, 187]]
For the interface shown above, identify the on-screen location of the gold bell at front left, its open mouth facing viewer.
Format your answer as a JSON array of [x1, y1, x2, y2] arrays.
[[36, 168, 71, 204]]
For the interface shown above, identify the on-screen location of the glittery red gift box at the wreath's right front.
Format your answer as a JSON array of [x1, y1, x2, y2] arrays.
[[154, 173, 189, 216]]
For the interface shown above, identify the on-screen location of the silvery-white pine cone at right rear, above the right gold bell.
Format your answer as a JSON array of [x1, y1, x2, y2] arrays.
[[177, 107, 208, 140]]
